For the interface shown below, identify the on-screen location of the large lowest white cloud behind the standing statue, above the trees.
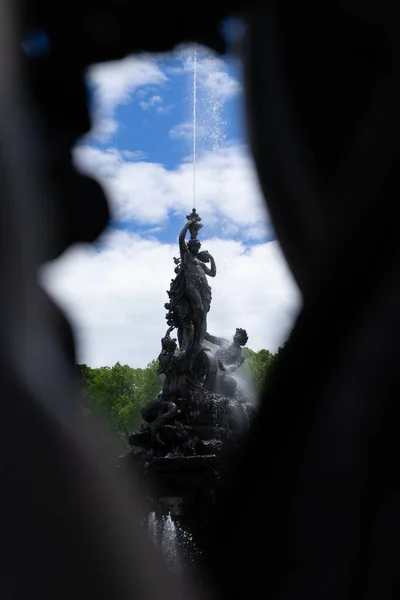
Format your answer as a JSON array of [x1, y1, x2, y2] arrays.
[[42, 228, 300, 367]]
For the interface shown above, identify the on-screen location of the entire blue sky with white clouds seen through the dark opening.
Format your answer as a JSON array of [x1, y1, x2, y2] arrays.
[[43, 47, 299, 366]]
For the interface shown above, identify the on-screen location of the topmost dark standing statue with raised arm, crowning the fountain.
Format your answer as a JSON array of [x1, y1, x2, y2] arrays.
[[165, 209, 217, 359]]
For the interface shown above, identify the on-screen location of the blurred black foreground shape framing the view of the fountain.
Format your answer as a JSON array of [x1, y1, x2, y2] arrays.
[[0, 0, 400, 600]]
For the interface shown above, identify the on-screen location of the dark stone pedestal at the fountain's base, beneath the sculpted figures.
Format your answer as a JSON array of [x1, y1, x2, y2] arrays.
[[123, 398, 253, 563]]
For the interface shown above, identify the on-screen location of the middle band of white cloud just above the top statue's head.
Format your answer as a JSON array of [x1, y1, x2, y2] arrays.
[[75, 146, 270, 238]]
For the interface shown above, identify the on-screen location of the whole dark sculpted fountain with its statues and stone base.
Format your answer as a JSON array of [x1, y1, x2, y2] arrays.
[[125, 209, 254, 561]]
